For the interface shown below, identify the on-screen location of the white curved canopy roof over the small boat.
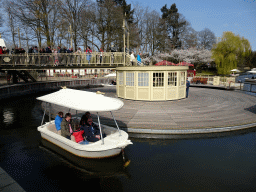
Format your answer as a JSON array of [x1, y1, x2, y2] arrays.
[[37, 89, 124, 111]]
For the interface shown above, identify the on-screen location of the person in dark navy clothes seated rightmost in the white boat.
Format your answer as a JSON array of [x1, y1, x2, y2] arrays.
[[81, 116, 100, 142]]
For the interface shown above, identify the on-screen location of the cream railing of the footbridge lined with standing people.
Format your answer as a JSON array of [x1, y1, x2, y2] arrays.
[[0, 52, 130, 67]]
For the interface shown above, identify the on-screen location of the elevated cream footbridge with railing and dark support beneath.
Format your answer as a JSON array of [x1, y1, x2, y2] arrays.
[[0, 52, 131, 83]]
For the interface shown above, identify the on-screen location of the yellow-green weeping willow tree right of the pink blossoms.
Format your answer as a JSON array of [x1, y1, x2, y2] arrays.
[[212, 31, 251, 75]]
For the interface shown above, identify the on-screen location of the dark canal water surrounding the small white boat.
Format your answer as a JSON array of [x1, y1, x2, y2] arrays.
[[0, 93, 256, 192]]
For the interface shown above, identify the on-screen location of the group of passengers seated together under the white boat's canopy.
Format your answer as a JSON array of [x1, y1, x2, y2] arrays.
[[55, 112, 105, 145]]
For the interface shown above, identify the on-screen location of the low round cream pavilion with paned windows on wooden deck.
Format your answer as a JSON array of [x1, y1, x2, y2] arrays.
[[116, 66, 188, 101]]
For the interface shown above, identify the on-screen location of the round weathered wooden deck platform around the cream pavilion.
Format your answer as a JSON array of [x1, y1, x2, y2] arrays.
[[44, 87, 256, 133]]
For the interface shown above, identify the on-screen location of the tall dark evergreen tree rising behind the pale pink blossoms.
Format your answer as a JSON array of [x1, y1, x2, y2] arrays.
[[161, 3, 187, 49]]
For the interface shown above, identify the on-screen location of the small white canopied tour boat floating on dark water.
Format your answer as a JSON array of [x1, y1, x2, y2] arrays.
[[37, 88, 132, 158]]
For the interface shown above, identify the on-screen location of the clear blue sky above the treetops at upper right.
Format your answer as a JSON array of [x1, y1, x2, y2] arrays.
[[126, 0, 256, 51]]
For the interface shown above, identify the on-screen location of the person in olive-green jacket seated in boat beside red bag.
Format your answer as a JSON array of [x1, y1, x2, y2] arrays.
[[60, 113, 74, 139]]
